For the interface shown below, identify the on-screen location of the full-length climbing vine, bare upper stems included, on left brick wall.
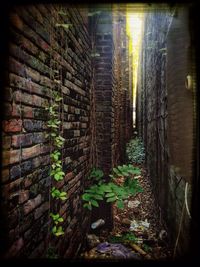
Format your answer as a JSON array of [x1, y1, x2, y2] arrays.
[[46, 7, 67, 239]]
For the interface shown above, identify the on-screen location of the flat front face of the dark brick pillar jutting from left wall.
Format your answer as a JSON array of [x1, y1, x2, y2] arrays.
[[93, 11, 113, 228]]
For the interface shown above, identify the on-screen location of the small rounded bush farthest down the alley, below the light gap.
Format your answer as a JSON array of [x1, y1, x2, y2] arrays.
[[126, 137, 145, 164]]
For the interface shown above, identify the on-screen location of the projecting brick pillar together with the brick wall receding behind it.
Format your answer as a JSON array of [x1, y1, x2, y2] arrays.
[[90, 7, 132, 228]]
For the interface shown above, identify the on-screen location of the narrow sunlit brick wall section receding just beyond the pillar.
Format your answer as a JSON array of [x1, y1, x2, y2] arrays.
[[113, 8, 133, 166]]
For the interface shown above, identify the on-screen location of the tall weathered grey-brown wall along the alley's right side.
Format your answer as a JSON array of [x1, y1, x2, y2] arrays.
[[137, 5, 195, 256]]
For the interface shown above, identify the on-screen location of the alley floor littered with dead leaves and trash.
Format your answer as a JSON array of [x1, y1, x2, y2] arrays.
[[81, 166, 172, 260]]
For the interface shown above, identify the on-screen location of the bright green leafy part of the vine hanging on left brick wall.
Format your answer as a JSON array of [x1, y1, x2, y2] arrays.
[[45, 91, 67, 236]]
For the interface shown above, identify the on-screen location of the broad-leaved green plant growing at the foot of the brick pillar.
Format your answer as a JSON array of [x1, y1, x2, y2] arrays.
[[82, 164, 142, 210]]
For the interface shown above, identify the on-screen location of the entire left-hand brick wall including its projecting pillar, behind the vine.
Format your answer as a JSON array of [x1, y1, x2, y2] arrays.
[[1, 4, 132, 258]]
